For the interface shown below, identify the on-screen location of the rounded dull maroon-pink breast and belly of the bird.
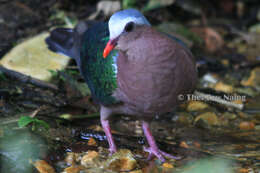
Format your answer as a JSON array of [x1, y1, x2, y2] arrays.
[[112, 27, 197, 115]]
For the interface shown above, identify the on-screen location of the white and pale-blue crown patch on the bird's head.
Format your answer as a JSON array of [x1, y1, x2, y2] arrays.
[[108, 9, 151, 40]]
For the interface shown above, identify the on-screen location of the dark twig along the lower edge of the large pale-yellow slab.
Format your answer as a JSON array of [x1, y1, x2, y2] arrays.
[[0, 65, 58, 90]]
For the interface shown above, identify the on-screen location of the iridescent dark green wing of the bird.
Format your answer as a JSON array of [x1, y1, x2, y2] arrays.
[[80, 23, 119, 105]]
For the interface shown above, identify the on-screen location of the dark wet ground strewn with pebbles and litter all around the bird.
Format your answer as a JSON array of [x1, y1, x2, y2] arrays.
[[0, 0, 260, 173]]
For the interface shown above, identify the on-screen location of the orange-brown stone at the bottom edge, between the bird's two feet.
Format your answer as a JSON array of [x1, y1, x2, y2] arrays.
[[107, 149, 137, 172]]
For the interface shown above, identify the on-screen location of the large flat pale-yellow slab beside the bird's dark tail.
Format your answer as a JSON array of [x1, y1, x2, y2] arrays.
[[0, 33, 69, 81]]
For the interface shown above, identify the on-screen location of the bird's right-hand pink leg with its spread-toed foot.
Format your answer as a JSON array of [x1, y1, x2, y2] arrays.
[[142, 121, 180, 162]]
